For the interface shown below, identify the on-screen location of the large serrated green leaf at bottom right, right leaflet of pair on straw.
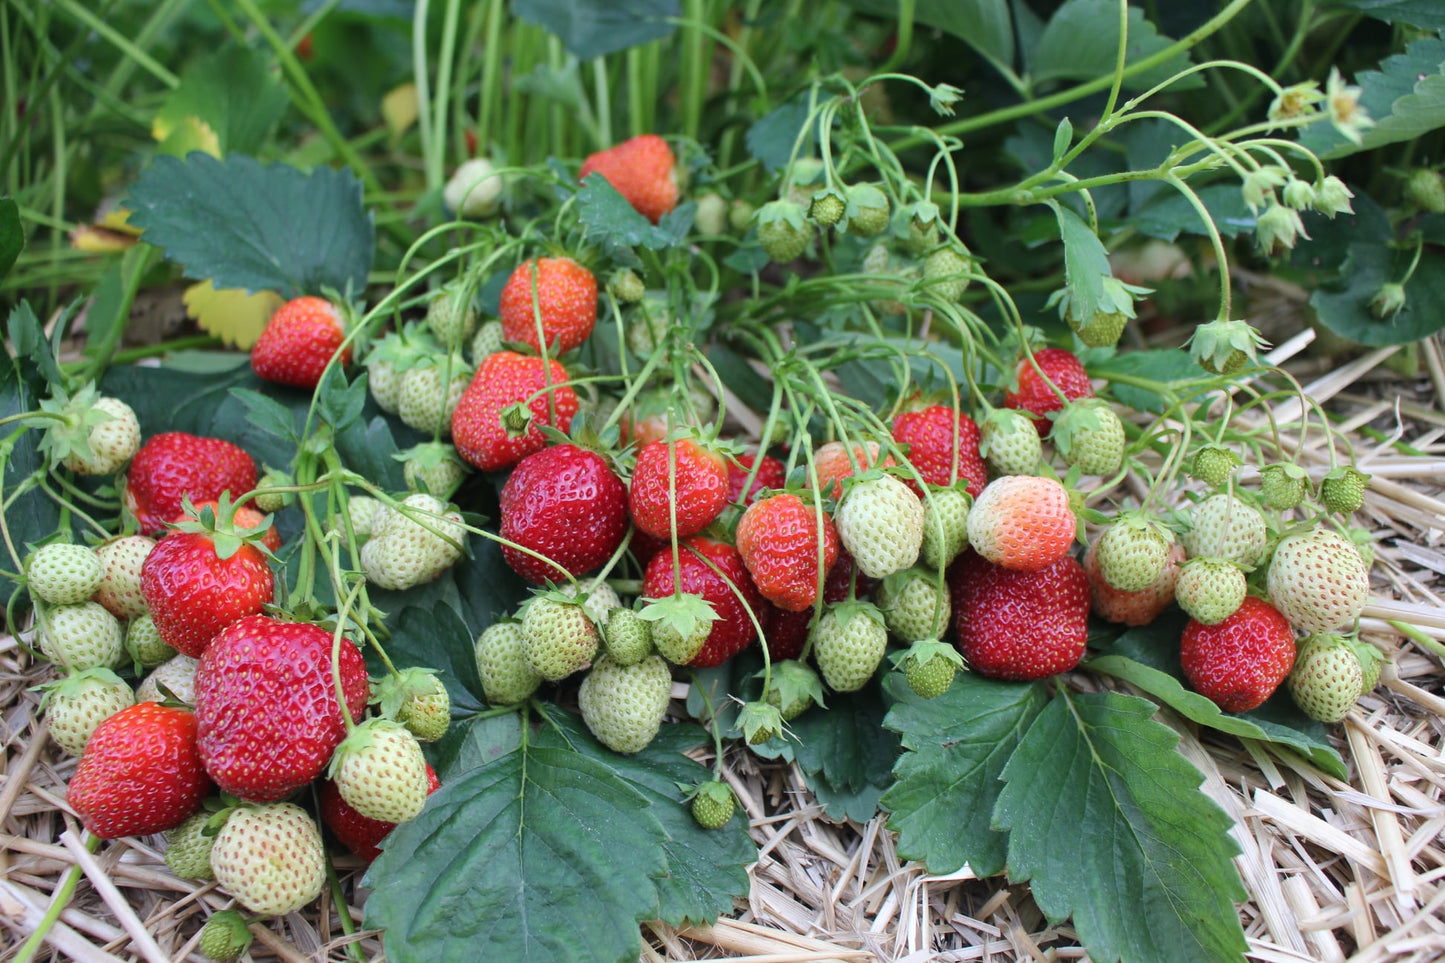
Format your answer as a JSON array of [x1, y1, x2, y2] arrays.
[[994, 690, 1246, 963]]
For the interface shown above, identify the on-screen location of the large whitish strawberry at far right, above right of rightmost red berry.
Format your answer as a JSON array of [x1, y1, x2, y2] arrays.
[[1267, 528, 1370, 635]]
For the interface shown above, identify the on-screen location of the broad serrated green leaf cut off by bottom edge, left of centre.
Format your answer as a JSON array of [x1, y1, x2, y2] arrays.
[[366, 734, 668, 963]]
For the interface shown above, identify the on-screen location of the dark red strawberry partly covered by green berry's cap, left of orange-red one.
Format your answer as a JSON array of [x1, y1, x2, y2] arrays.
[[642, 536, 763, 668]]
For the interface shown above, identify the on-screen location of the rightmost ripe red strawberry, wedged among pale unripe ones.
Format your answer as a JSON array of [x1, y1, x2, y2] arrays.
[[1179, 596, 1295, 713]]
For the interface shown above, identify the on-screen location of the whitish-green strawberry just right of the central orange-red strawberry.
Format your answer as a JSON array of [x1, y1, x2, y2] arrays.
[[832, 474, 923, 578]]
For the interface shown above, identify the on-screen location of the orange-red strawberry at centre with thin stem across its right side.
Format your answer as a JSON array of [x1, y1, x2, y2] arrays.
[[737, 492, 838, 612]]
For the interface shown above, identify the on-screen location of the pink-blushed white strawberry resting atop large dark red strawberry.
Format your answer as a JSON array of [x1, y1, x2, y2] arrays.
[[968, 474, 1078, 571]]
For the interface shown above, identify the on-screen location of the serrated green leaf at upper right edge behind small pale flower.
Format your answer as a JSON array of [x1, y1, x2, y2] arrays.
[[1299, 36, 1445, 159]]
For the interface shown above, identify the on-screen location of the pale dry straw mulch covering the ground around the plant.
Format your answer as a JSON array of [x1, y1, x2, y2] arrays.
[[0, 333, 1445, 963]]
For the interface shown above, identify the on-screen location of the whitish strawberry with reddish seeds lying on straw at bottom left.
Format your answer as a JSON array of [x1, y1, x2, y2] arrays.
[[211, 803, 327, 917]]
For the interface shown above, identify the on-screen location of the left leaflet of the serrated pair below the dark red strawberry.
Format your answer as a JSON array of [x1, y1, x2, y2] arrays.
[[883, 672, 1048, 876]]
